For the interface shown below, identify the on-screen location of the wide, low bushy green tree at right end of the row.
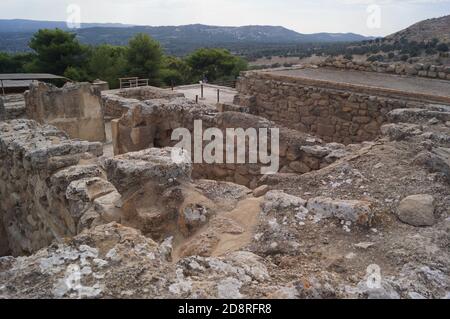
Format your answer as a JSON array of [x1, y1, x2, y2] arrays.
[[186, 49, 248, 81]]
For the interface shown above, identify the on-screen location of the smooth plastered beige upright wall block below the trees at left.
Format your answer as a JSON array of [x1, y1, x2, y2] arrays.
[[25, 82, 106, 142]]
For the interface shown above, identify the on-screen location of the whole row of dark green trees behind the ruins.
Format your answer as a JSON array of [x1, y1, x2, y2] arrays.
[[0, 29, 247, 88]]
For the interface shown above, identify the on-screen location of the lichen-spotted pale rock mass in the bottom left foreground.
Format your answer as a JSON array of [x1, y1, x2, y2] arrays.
[[0, 223, 269, 299]]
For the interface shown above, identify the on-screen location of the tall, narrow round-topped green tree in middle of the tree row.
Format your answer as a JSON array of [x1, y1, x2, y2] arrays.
[[127, 33, 163, 85]]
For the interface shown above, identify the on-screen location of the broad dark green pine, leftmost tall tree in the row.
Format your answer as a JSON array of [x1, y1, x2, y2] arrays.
[[28, 29, 87, 75]]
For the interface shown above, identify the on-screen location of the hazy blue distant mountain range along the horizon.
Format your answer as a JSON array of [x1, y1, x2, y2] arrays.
[[0, 20, 373, 55]]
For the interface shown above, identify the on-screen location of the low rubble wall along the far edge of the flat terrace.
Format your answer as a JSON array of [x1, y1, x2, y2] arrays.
[[319, 58, 450, 80]]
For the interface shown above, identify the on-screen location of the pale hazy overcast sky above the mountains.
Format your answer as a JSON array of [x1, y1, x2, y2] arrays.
[[0, 0, 450, 36]]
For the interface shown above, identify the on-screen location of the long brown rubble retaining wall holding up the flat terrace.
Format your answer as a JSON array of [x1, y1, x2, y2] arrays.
[[236, 72, 444, 144]]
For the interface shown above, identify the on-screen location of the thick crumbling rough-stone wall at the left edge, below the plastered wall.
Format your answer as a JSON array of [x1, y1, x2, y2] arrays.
[[0, 120, 120, 255]]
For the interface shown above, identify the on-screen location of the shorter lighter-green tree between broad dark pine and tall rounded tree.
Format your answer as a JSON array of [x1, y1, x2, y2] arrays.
[[87, 44, 127, 88]]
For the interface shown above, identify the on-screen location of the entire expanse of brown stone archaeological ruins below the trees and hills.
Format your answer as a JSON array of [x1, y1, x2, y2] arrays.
[[0, 60, 450, 298]]
